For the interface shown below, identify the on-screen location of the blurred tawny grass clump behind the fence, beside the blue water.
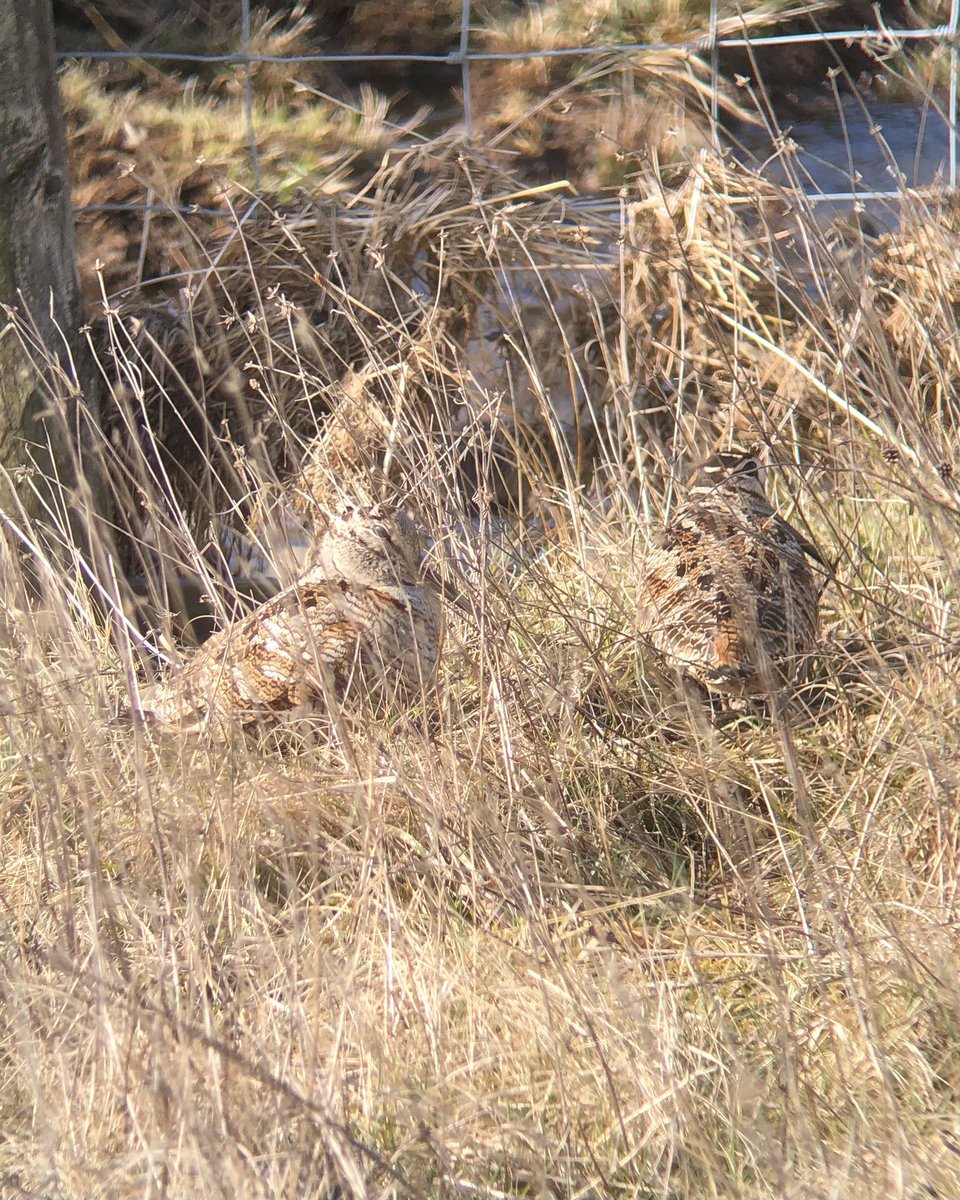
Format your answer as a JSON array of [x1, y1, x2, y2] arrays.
[[470, 0, 816, 191]]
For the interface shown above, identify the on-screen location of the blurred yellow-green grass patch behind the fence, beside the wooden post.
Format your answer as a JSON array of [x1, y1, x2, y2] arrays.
[[60, 64, 425, 301]]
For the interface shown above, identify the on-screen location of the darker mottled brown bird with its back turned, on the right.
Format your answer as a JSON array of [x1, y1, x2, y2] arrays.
[[638, 454, 823, 696]]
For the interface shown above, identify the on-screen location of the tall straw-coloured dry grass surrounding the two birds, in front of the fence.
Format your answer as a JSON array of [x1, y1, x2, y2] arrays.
[[0, 126, 960, 1200]]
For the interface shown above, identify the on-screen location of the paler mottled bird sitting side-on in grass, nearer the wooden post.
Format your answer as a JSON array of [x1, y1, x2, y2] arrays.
[[142, 505, 442, 730]]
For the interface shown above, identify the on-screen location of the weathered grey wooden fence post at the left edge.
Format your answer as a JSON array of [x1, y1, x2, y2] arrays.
[[0, 0, 103, 530]]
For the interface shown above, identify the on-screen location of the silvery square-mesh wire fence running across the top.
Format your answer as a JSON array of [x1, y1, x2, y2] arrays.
[[58, 0, 960, 215]]
